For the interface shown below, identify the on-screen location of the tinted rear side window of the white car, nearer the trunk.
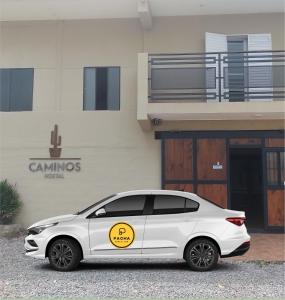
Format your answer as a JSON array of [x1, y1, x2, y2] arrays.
[[153, 195, 199, 215]]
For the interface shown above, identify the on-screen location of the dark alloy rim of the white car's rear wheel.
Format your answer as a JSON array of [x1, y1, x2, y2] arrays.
[[190, 243, 215, 268]]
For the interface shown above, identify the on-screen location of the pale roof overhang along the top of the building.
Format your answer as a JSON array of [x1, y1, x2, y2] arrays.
[[0, 0, 284, 22]]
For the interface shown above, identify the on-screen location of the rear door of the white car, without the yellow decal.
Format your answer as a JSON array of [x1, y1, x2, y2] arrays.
[[142, 194, 199, 257]]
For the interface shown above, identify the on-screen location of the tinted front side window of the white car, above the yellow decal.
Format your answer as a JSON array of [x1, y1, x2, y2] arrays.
[[104, 195, 146, 217]]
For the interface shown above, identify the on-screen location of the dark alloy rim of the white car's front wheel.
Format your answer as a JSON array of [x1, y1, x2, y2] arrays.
[[51, 242, 73, 268]]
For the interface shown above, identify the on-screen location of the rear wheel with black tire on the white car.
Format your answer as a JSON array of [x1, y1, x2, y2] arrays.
[[185, 239, 219, 272]]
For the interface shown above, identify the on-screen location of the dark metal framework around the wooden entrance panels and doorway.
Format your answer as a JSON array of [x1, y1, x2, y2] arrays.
[[155, 130, 285, 232]]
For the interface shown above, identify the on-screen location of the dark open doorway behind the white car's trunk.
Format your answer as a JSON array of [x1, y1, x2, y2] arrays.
[[230, 148, 264, 231]]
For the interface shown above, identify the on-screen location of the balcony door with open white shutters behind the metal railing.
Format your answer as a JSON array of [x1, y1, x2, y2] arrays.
[[205, 32, 273, 102]]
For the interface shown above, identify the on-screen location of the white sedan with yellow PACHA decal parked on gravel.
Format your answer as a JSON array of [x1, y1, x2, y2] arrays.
[[25, 190, 250, 271]]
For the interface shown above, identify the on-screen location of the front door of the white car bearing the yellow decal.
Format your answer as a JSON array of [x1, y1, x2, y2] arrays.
[[89, 195, 146, 256]]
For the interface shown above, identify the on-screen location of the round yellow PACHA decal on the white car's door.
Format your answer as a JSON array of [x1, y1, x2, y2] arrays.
[[109, 223, 135, 248]]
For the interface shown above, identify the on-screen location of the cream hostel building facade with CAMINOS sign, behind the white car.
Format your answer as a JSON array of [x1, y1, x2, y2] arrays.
[[0, 1, 284, 229]]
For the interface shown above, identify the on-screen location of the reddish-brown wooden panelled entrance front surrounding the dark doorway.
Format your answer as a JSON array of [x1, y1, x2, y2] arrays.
[[162, 132, 285, 230]]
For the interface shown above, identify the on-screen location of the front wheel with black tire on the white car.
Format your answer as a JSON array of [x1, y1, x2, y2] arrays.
[[48, 238, 82, 272]]
